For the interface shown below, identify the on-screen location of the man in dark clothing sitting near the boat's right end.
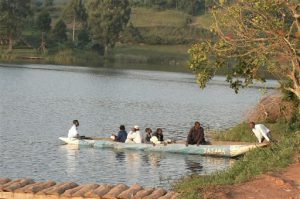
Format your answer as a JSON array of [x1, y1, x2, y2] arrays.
[[186, 122, 206, 146]]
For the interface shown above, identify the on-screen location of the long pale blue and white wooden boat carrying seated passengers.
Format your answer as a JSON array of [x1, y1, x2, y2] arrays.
[[59, 137, 267, 157]]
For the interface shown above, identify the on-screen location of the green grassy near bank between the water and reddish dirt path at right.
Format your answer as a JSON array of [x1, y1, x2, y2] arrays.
[[174, 123, 300, 199]]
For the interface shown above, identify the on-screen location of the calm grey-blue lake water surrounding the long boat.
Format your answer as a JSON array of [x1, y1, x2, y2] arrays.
[[0, 65, 276, 188]]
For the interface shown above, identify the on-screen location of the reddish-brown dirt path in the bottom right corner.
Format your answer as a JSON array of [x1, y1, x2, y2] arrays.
[[211, 163, 300, 199]]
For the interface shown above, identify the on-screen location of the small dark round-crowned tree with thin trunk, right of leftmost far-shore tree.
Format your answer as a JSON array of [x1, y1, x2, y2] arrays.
[[36, 10, 51, 53]]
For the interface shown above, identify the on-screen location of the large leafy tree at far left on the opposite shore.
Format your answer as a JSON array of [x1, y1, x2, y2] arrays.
[[0, 0, 30, 51]]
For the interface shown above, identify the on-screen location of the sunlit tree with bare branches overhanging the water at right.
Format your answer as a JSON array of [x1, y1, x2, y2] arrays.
[[189, 0, 300, 102]]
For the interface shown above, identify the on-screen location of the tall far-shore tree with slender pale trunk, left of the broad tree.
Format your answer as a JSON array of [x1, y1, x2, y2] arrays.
[[65, 0, 87, 42]]
